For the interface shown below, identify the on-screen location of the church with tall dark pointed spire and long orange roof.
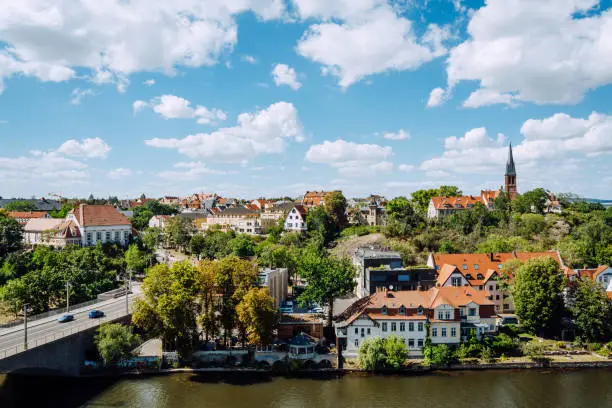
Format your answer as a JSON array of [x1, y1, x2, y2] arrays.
[[427, 144, 518, 218]]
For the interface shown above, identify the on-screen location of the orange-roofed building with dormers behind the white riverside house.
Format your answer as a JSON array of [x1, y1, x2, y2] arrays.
[[427, 251, 571, 313]]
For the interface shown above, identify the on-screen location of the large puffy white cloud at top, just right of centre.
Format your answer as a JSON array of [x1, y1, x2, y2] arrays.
[[297, 1, 444, 88]]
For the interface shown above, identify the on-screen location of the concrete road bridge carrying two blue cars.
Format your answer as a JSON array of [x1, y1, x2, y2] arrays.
[[0, 287, 140, 376]]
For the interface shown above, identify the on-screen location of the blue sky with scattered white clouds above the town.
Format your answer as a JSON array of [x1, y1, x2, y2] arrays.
[[0, 0, 612, 199]]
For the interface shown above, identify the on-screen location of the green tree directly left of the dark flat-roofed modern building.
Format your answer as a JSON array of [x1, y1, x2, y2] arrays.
[[298, 248, 356, 326]]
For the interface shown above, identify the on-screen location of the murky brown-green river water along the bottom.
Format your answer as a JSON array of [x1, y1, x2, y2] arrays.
[[0, 369, 612, 408]]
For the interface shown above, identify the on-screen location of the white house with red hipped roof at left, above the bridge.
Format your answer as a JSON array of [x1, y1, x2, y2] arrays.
[[66, 204, 132, 246]]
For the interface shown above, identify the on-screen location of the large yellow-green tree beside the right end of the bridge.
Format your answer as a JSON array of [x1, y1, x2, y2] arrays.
[[132, 261, 201, 356]]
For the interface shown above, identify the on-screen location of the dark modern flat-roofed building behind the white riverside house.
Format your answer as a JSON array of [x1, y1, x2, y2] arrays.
[[353, 247, 436, 297]]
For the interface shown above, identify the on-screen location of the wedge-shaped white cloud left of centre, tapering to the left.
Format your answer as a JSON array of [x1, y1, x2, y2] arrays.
[[145, 102, 304, 162]]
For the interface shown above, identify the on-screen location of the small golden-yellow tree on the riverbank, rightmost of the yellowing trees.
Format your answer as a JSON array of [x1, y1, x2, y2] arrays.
[[236, 288, 278, 344]]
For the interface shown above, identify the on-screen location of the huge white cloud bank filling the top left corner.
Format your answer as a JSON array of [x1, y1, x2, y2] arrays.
[[0, 0, 285, 91]]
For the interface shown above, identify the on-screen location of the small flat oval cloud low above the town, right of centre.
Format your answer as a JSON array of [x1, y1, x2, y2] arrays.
[[305, 139, 393, 177]]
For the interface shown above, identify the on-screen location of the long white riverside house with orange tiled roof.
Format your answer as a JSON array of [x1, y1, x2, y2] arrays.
[[335, 286, 496, 357]]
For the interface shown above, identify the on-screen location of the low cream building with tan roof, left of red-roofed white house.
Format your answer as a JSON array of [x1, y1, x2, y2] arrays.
[[23, 218, 81, 248]]
